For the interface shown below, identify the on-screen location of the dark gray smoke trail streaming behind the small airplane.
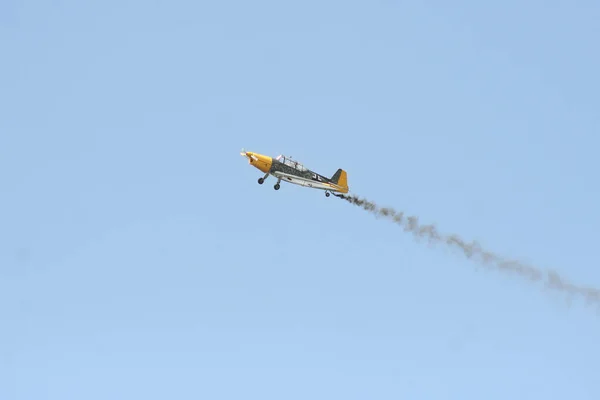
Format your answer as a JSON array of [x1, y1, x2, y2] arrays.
[[336, 194, 600, 304]]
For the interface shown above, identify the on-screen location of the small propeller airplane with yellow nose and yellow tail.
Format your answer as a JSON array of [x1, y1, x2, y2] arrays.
[[240, 149, 349, 197]]
